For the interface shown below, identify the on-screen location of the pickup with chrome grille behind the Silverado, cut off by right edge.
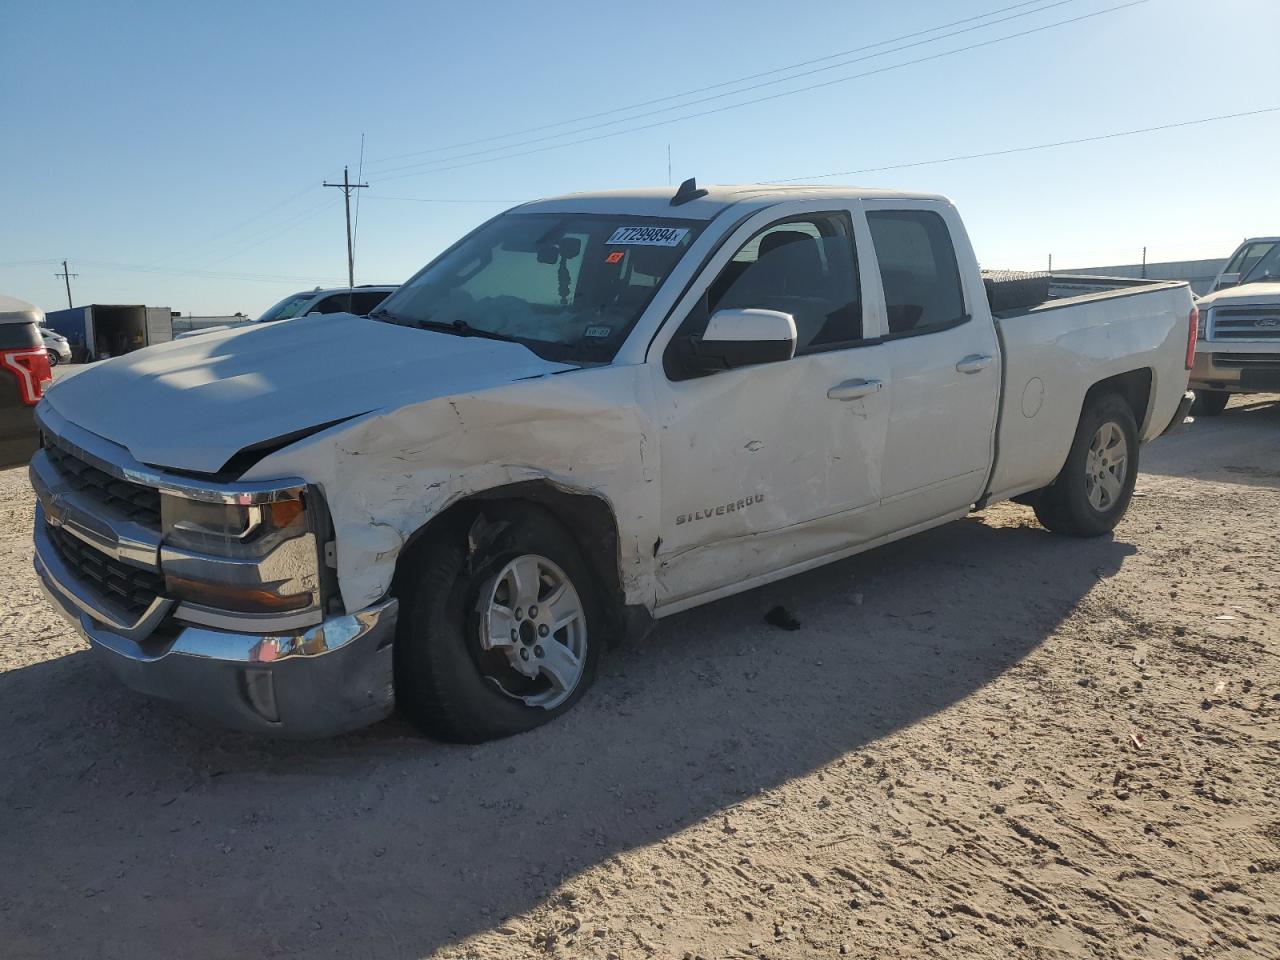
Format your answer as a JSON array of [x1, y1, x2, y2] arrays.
[[1190, 237, 1280, 416]]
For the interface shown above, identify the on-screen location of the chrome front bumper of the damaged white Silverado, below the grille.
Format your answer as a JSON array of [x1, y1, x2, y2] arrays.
[[35, 516, 399, 739]]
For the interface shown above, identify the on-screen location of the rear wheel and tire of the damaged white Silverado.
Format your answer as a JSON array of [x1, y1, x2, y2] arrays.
[[1036, 393, 1138, 536]]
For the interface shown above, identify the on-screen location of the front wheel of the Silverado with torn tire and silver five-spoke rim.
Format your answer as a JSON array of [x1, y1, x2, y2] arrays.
[[394, 504, 604, 744]]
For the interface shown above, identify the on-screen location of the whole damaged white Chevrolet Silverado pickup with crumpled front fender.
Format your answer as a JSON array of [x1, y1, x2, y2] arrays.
[[31, 182, 1196, 741]]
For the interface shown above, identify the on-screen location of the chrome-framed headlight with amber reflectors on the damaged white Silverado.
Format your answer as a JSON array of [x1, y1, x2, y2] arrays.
[[160, 494, 320, 622]]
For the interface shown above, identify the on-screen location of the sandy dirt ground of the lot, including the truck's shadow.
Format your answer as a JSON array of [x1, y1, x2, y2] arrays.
[[0, 398, 1280, 960]]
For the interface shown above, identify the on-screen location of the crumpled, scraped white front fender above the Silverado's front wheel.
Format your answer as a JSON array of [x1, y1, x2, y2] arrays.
[[244, 366, 659, 609]]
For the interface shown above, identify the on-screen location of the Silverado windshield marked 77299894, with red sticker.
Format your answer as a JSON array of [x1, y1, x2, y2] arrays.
[[371, 214, 703, 362]]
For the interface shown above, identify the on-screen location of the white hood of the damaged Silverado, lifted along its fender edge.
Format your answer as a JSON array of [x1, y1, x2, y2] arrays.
[[44, 314, 573, 474]]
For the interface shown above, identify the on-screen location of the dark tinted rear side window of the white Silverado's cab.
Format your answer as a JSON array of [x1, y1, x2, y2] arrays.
[[867, 210, 969, 338]]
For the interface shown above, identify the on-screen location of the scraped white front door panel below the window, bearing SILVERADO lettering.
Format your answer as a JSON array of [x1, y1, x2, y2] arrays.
[[655, 346, 888, 605]]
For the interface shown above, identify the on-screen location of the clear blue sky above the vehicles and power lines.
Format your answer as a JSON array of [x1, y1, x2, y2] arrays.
[[0, 0, 1280, 315]]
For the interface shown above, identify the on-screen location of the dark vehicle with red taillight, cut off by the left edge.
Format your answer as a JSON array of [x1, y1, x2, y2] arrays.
[[0, 296, 54, 468]]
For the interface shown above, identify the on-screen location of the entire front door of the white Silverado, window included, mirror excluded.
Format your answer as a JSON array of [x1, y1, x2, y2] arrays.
[[650, 201, 888, 612]]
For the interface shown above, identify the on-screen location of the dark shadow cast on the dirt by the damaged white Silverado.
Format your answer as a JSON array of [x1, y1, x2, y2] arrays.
[[0, 515, 1134, 957]]
